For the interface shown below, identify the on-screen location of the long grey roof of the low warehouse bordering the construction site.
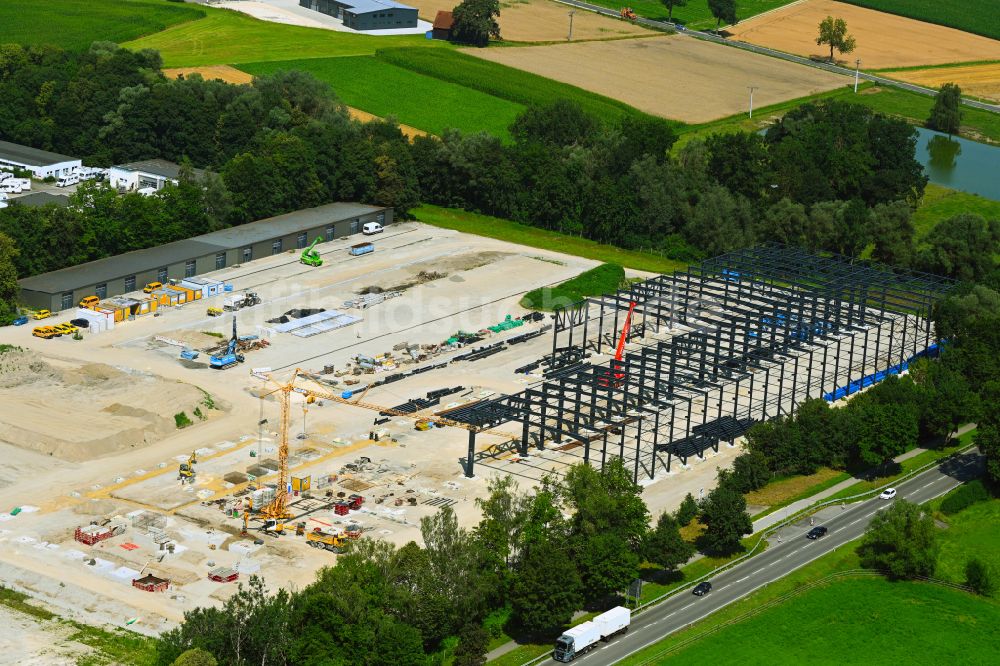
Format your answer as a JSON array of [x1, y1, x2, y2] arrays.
[[18, 203, 384, 294]]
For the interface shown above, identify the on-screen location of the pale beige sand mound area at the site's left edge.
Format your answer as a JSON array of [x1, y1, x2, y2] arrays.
[[0, 351, 225, 461]]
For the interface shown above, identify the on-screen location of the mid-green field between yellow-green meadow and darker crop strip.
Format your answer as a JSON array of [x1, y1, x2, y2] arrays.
[[239, 56, 524, 139]]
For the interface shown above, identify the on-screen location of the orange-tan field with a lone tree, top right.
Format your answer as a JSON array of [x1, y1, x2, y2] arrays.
[[727, 0, 1000, 69]]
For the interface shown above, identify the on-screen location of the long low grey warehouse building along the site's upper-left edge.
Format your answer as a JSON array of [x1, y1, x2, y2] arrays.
[[19, 203, 393, 312]]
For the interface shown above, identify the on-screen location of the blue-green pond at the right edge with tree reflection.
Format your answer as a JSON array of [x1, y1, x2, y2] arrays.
[[916, 127, 1000, 201]]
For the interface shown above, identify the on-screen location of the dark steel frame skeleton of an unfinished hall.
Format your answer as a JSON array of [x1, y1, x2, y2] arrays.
[[449, 244, 954, 481]]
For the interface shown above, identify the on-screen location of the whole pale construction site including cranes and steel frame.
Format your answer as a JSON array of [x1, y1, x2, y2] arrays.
[[0, 222, 952, 634]]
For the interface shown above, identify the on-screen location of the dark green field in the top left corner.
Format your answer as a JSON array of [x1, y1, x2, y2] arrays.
[[0, 0, 205, 50]]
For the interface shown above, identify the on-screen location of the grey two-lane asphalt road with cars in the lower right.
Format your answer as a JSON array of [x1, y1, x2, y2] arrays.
[[542, 452, 982, 666]]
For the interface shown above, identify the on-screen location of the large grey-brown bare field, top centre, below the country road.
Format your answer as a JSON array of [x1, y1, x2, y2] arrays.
[[465, 35, 847, 123]]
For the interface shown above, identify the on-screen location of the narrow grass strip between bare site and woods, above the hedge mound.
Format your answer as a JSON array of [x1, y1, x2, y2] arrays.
[[411, 204, 685, 273]]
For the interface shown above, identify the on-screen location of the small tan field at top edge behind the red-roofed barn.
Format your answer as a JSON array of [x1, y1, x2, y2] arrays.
[[407, 0, 656, 42]]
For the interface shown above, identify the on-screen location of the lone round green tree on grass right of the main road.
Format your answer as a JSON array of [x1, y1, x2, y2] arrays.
[[857, 500, 938, 579]]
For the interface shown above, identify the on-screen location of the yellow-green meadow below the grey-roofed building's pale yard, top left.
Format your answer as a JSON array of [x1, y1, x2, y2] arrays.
[[123, 7, 447, 67]]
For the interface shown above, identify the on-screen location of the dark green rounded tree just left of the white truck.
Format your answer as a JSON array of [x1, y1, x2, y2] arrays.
[[511, 542, 583, 633]]
